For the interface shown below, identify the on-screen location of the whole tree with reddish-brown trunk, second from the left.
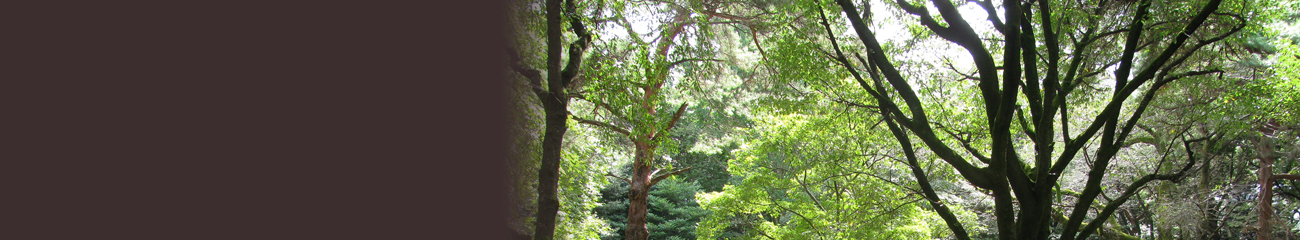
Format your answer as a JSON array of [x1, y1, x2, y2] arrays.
[[572, 3, 706, 240]]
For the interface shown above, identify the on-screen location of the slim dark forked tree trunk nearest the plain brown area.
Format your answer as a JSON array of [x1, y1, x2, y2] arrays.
[[507, 0, 592, 240]]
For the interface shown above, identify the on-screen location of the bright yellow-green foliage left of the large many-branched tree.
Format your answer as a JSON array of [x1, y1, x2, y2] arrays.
[[697, 110, 941, 239]]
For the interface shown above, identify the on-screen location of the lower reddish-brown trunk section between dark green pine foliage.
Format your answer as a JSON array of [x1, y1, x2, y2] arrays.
[[624, 141, 654, 240]]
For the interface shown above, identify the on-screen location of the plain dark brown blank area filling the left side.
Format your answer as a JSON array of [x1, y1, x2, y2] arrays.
[[10, 1, 506, 240]]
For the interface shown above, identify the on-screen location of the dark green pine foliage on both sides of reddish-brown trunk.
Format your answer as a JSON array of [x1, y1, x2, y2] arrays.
[[594, 166, 709, 240]]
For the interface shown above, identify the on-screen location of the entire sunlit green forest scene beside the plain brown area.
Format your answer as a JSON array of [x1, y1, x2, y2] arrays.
[[503, 0, 1300, 240]]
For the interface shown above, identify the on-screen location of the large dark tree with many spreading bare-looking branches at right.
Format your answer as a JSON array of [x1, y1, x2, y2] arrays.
[[790, 0, 1249, 240]]
